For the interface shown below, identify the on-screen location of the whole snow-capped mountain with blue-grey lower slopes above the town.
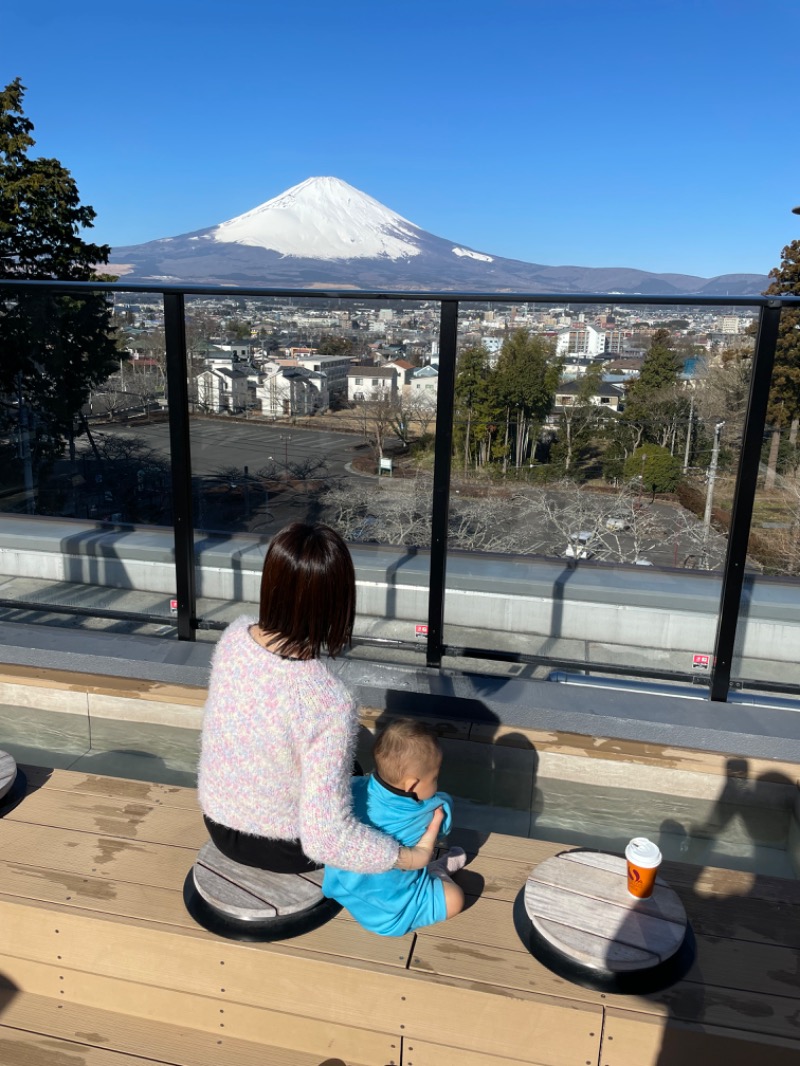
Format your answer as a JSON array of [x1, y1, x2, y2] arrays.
[[103, 177, 768, 296]]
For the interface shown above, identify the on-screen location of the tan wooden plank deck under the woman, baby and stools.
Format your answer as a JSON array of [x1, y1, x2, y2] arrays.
[[0, 768, 800, 1066]]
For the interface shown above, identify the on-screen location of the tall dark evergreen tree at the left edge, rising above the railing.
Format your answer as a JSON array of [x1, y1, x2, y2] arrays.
[[0, 79, 119, 472]]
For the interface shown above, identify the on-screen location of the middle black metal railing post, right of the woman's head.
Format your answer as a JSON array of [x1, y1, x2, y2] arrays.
[[426, 300, 459, 668]]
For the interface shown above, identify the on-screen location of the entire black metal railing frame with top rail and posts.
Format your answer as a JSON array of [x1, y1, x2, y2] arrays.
[[0, 279, 800, 702]]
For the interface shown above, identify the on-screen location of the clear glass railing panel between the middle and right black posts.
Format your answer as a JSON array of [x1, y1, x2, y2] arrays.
[[445, 303, 754, 682]]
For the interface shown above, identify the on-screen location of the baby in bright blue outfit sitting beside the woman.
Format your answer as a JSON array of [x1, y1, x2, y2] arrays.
[[322, 718, 466, 936]]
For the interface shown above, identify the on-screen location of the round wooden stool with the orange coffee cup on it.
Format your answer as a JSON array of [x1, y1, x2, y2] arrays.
[[515, 850, 693, 994]]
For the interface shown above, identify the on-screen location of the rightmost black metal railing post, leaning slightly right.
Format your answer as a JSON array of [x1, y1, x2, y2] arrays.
[[710, 302, 781, 702]]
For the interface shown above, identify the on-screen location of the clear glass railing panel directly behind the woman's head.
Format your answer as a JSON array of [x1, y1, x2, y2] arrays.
[[187, 297, 438, 645]]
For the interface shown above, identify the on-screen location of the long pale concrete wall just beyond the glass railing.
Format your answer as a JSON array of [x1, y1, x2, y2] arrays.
[[0, 516, 800, 663]]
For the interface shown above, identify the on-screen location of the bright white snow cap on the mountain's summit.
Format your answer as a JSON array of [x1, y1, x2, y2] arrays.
[[209, 178, 422, 259]]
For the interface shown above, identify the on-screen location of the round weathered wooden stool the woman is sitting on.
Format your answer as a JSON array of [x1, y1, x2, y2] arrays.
[[183, 840, 341, 940]]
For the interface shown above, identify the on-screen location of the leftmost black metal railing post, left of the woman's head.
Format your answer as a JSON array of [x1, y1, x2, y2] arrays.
[[164, 292, 197, 641]]
